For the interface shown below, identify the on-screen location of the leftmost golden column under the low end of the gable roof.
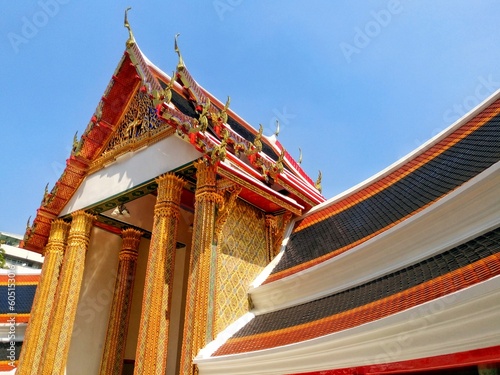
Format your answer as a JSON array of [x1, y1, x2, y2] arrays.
[[17, 220, 69, 375]]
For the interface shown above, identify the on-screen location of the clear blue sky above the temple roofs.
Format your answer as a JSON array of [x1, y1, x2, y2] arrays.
[[0, 0, 500, 234]]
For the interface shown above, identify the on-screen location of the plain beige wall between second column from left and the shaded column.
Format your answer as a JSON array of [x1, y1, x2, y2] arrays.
[[66, 227, 122, 375]]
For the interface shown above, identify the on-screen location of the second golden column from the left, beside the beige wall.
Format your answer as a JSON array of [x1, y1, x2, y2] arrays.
[[37, 211, 95, 375]]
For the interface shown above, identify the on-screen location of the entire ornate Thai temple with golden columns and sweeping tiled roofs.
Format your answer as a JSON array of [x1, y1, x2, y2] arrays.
[[16, 18, 500, 375]]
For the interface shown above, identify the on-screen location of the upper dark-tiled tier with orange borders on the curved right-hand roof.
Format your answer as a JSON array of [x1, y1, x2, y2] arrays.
[[266, 94, 500, 282]]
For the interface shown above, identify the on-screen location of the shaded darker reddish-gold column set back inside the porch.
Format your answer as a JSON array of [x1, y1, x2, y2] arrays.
[[99, 228, 142, 375]]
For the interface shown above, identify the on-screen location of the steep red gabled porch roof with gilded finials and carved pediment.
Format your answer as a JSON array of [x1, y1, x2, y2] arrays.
[[22, 33, 325, 252]]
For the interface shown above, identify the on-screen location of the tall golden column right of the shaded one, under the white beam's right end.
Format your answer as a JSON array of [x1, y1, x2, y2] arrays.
[[134, 174, 185, 375]]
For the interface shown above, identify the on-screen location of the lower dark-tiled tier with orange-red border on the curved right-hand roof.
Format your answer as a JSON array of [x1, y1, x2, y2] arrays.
[[213, 228, 500, 356]]
